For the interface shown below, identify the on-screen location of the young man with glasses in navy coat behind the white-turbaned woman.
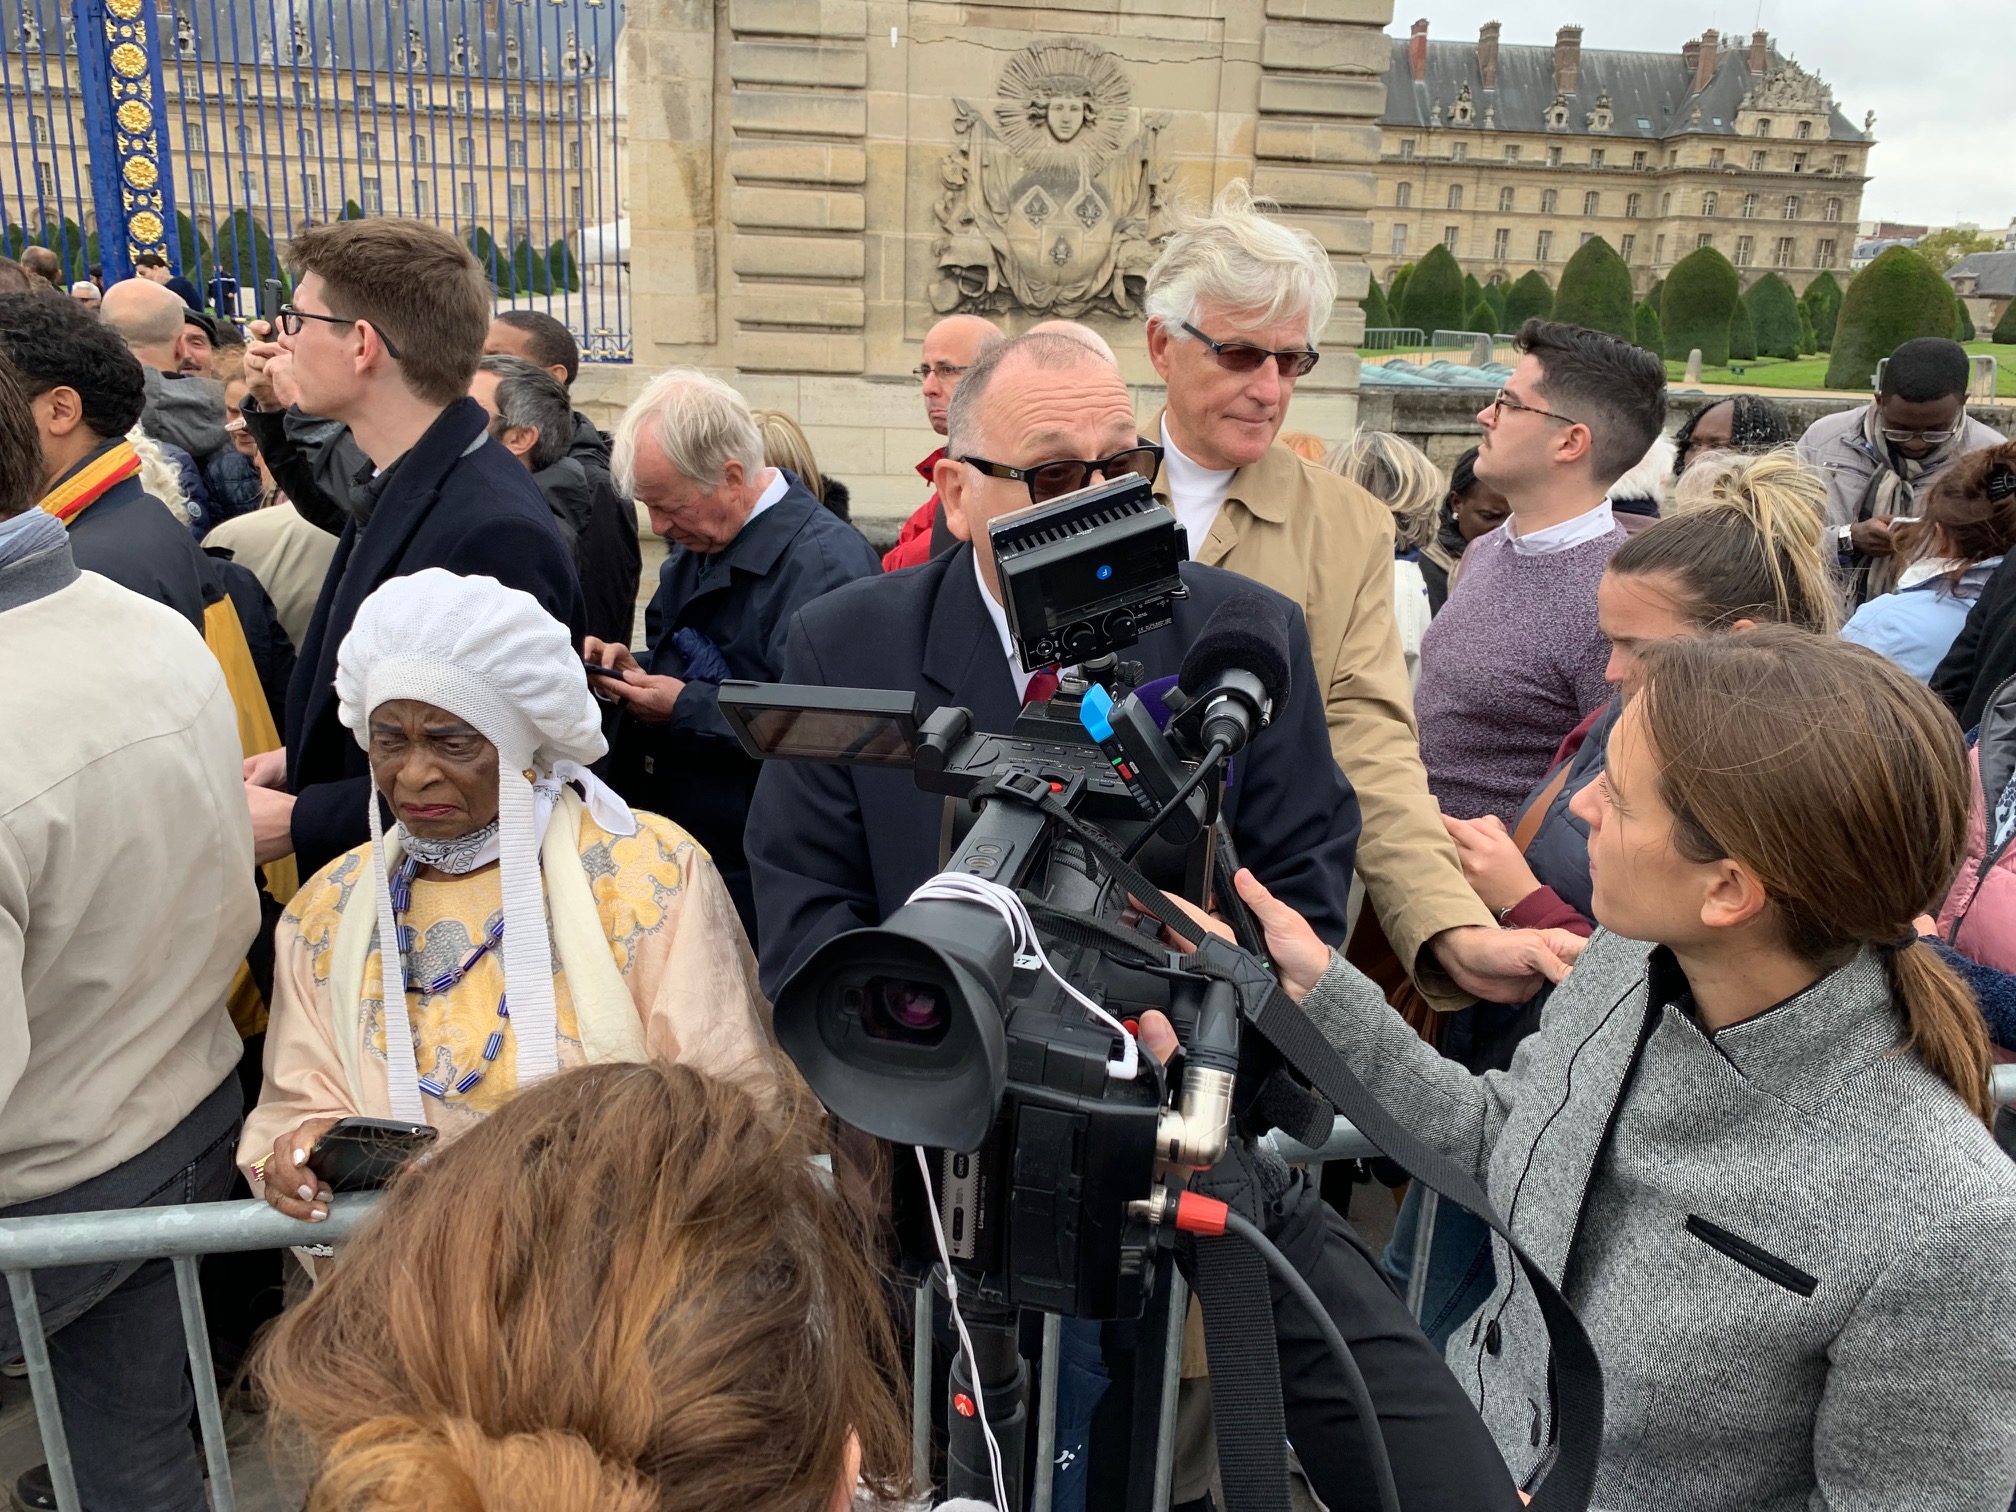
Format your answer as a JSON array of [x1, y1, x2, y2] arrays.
[[246, 218, 585, 879]]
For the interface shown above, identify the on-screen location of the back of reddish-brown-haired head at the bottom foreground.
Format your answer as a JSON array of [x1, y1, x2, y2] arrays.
[[252, 1060, 909, 1512]]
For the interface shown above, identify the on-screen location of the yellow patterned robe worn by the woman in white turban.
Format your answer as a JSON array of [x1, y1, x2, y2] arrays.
[[238, 810, 780, 1177]]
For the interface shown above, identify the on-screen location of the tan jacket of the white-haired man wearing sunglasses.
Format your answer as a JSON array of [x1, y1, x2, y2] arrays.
[[1151, 435, 1492, 1008]]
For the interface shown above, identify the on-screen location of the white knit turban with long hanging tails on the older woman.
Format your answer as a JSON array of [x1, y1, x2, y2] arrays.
[[337, 566, 609, 1123]]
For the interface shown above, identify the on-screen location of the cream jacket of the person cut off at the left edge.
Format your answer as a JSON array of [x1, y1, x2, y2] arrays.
[[0, 564, 258, 1208]]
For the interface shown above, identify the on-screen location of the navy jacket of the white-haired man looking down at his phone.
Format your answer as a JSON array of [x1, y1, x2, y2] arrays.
[[609, 472, 881, 939]]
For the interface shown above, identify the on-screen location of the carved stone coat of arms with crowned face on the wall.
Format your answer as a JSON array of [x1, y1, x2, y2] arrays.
[[931, 40, 1171, 317]]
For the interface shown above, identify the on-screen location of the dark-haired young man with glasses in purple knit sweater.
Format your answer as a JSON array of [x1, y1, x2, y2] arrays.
[[1415, 321, 1665, 825]]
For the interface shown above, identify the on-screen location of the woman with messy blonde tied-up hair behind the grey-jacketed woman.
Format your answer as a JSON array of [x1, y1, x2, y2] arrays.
[[1385, 452, 1837, 1343]]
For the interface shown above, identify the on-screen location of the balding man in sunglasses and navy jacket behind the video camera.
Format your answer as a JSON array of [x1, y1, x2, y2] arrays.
[[748, 335, 1387, 996]]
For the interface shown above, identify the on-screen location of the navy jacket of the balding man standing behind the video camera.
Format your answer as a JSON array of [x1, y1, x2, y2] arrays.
[[748, 544, 1359, 998]]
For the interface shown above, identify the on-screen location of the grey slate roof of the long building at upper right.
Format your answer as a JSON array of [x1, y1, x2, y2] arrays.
[[1379, 36, 1863, 141]]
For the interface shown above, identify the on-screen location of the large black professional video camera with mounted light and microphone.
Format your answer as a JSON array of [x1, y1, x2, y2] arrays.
[[720, 478, 1288, 1318]]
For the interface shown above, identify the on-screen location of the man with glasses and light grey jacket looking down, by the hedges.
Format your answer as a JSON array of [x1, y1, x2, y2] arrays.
[[1798, 337, 2002, 609]]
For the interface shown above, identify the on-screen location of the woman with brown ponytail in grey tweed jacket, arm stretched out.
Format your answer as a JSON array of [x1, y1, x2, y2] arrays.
[[1169, 628, 2016, 1512]]
